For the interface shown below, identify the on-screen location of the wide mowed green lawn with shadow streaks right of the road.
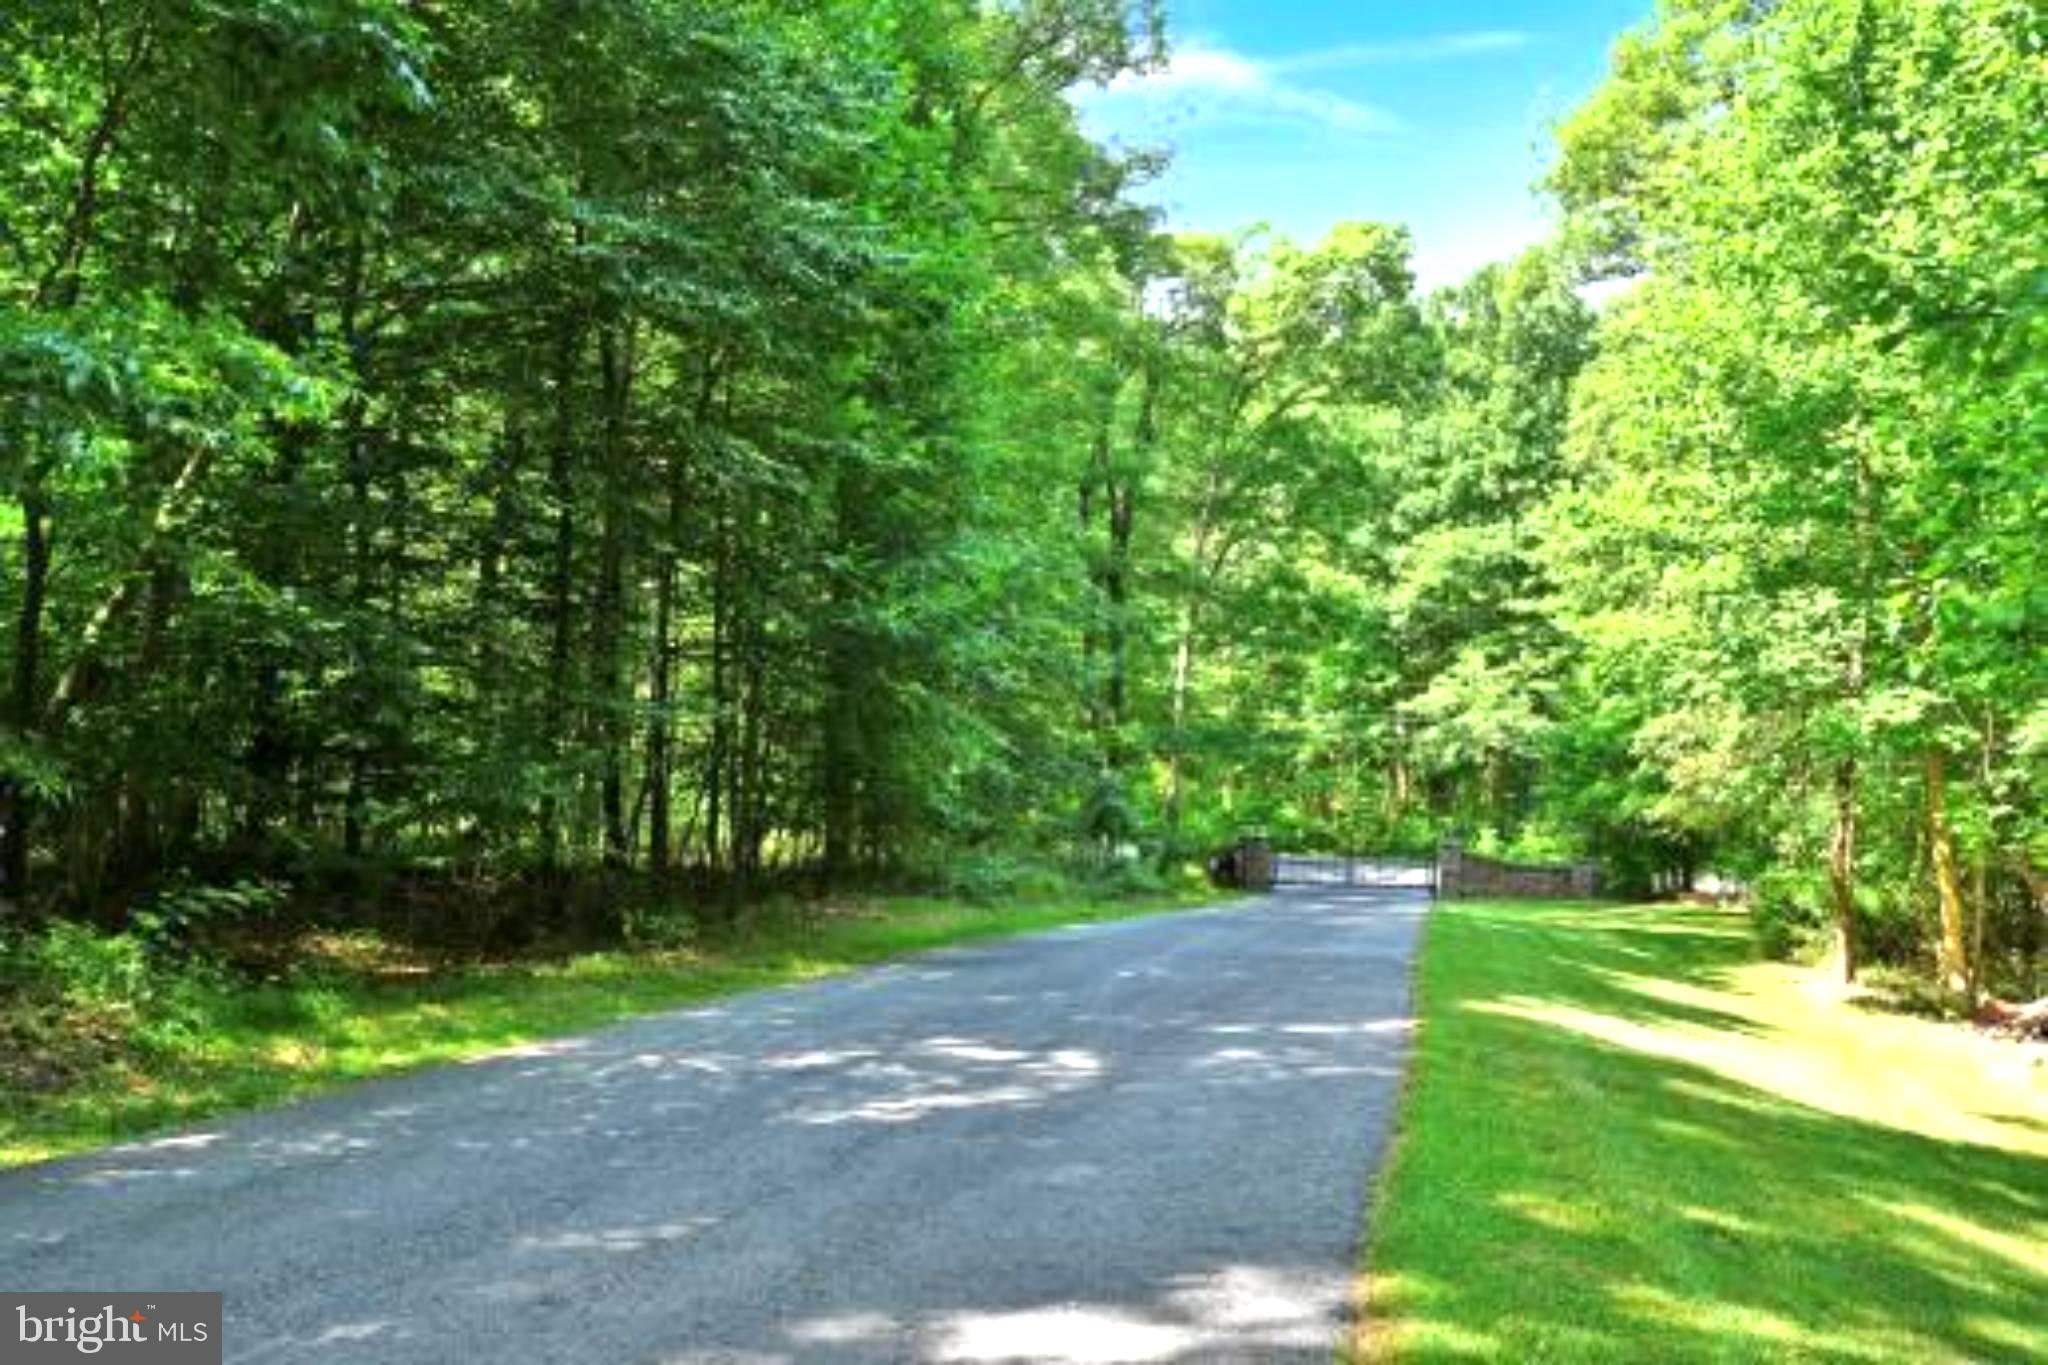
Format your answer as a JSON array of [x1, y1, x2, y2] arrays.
[[1358, 902, 2048, 1365]]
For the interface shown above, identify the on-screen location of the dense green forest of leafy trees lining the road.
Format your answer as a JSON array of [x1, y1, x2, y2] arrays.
[[0, 0, 2048, 995]]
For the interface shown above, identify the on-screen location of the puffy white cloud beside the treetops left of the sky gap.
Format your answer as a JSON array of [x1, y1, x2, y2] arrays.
[[1075, 45, 1401, 135]]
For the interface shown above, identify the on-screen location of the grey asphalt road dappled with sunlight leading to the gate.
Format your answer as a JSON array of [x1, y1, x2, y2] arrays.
[[0, 890, 1425, 1365]]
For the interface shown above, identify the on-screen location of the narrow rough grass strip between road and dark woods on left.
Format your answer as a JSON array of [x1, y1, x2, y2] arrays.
[[0, 888, 1223, 1169]]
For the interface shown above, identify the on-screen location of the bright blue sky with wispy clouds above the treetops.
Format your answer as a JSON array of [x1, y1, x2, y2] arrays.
[[1077, 0, 1651, 289]]
